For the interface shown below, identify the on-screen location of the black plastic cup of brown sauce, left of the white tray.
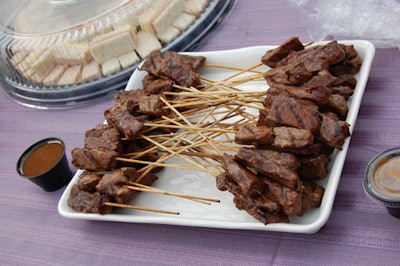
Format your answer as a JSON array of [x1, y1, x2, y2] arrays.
[[17, 138, 72, 191]]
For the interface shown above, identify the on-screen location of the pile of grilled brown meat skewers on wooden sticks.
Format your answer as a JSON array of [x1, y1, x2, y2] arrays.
[[68, 38, 360, 224]]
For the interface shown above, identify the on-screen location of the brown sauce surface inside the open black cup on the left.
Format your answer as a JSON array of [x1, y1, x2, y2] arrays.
[[22, 143, 64, 177]]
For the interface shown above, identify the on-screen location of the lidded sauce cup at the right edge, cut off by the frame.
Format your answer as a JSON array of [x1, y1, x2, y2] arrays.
[[364, 147, 400, 218]]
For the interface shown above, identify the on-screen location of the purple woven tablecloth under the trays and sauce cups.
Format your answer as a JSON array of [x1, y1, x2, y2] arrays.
[[0, 0, 400, 265]]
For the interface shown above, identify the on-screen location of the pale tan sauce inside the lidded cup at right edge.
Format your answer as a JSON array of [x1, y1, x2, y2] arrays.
[[372, 157, 400, 199]]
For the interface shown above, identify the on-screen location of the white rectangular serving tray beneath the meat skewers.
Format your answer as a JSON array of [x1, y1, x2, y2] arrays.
[[58, 40, 375, 233]]
